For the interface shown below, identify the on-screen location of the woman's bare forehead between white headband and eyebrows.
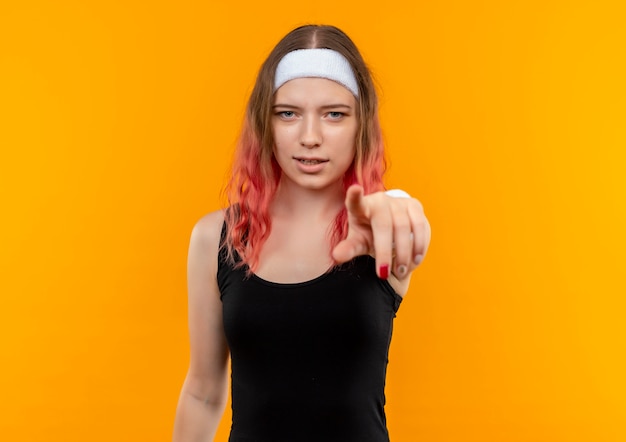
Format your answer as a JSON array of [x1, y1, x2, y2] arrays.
[[274, 78, 356, 106]]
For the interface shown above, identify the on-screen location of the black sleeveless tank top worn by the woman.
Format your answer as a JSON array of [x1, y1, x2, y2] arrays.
[[217, 233, 402, 442]]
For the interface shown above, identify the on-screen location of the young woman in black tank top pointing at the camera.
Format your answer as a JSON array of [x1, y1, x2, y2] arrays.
[[174, 26, 430, 442]]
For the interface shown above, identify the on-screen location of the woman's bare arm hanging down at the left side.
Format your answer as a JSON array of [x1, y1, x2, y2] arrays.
[[173, 212, 229, 442]]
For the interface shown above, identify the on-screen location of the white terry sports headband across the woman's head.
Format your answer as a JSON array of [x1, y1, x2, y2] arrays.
[[274, 48, 359, 97]]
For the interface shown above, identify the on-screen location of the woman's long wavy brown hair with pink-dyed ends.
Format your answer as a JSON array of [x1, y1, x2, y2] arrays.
[[222, 25, 385, 273]]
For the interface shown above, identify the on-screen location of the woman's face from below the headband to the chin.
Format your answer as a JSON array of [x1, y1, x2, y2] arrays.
[[272, 78, 358, 190]]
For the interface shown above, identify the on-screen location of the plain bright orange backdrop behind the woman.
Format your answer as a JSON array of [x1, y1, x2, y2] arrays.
[[0, 0, 626, 442]]
